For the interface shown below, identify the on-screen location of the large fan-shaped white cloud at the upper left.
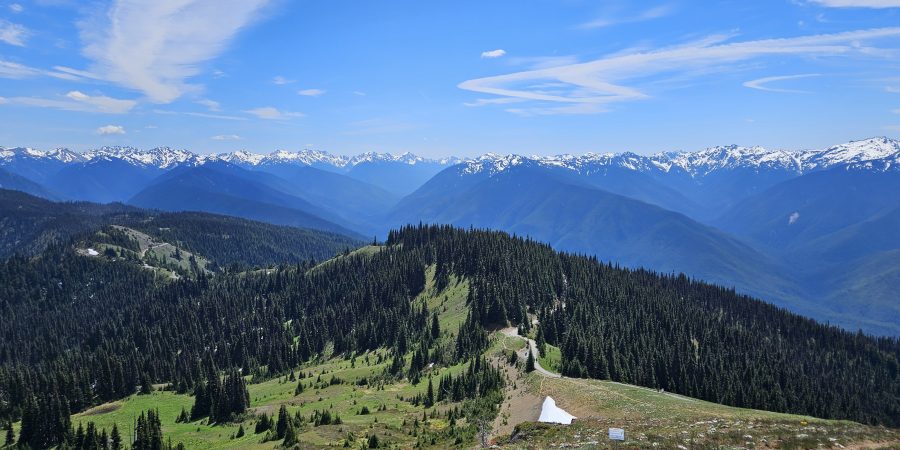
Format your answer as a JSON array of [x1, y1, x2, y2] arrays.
[[80, 0, 268, 103]]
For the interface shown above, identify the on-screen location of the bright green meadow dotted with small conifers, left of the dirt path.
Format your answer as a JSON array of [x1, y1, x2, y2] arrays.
[[59, 262, 482, 449]]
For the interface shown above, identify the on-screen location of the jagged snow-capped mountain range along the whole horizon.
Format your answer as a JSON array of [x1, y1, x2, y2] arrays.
[[0, 137, 900, 177]]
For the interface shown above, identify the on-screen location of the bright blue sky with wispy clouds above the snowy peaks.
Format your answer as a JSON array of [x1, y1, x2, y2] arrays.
[[0, 0, 900, 157]]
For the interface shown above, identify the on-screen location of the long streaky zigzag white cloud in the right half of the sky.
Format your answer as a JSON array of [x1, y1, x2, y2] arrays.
[[459, 27, 900, 115]]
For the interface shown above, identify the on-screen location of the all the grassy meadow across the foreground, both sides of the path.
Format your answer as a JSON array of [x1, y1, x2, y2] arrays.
[[49, 264, 900, 449]]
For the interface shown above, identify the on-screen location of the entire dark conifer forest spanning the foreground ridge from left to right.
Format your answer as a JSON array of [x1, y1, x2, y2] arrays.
[[0, 223, 900, 444]]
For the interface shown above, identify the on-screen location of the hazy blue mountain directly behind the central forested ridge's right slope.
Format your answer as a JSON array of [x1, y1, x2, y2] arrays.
[[390, 163, 798, 310]]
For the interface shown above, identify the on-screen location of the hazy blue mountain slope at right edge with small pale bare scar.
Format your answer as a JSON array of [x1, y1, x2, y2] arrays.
[[720, 171, 900, 335]]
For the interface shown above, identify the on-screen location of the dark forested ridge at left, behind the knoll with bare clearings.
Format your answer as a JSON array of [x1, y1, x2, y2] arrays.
[[0, 189, 361, 266]]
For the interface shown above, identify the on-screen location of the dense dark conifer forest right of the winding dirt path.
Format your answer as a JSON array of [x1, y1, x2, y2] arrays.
[[388, 226, 900, 426]]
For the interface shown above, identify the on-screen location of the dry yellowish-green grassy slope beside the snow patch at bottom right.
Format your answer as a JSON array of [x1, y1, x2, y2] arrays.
[[496, 374, 900, 449]]
